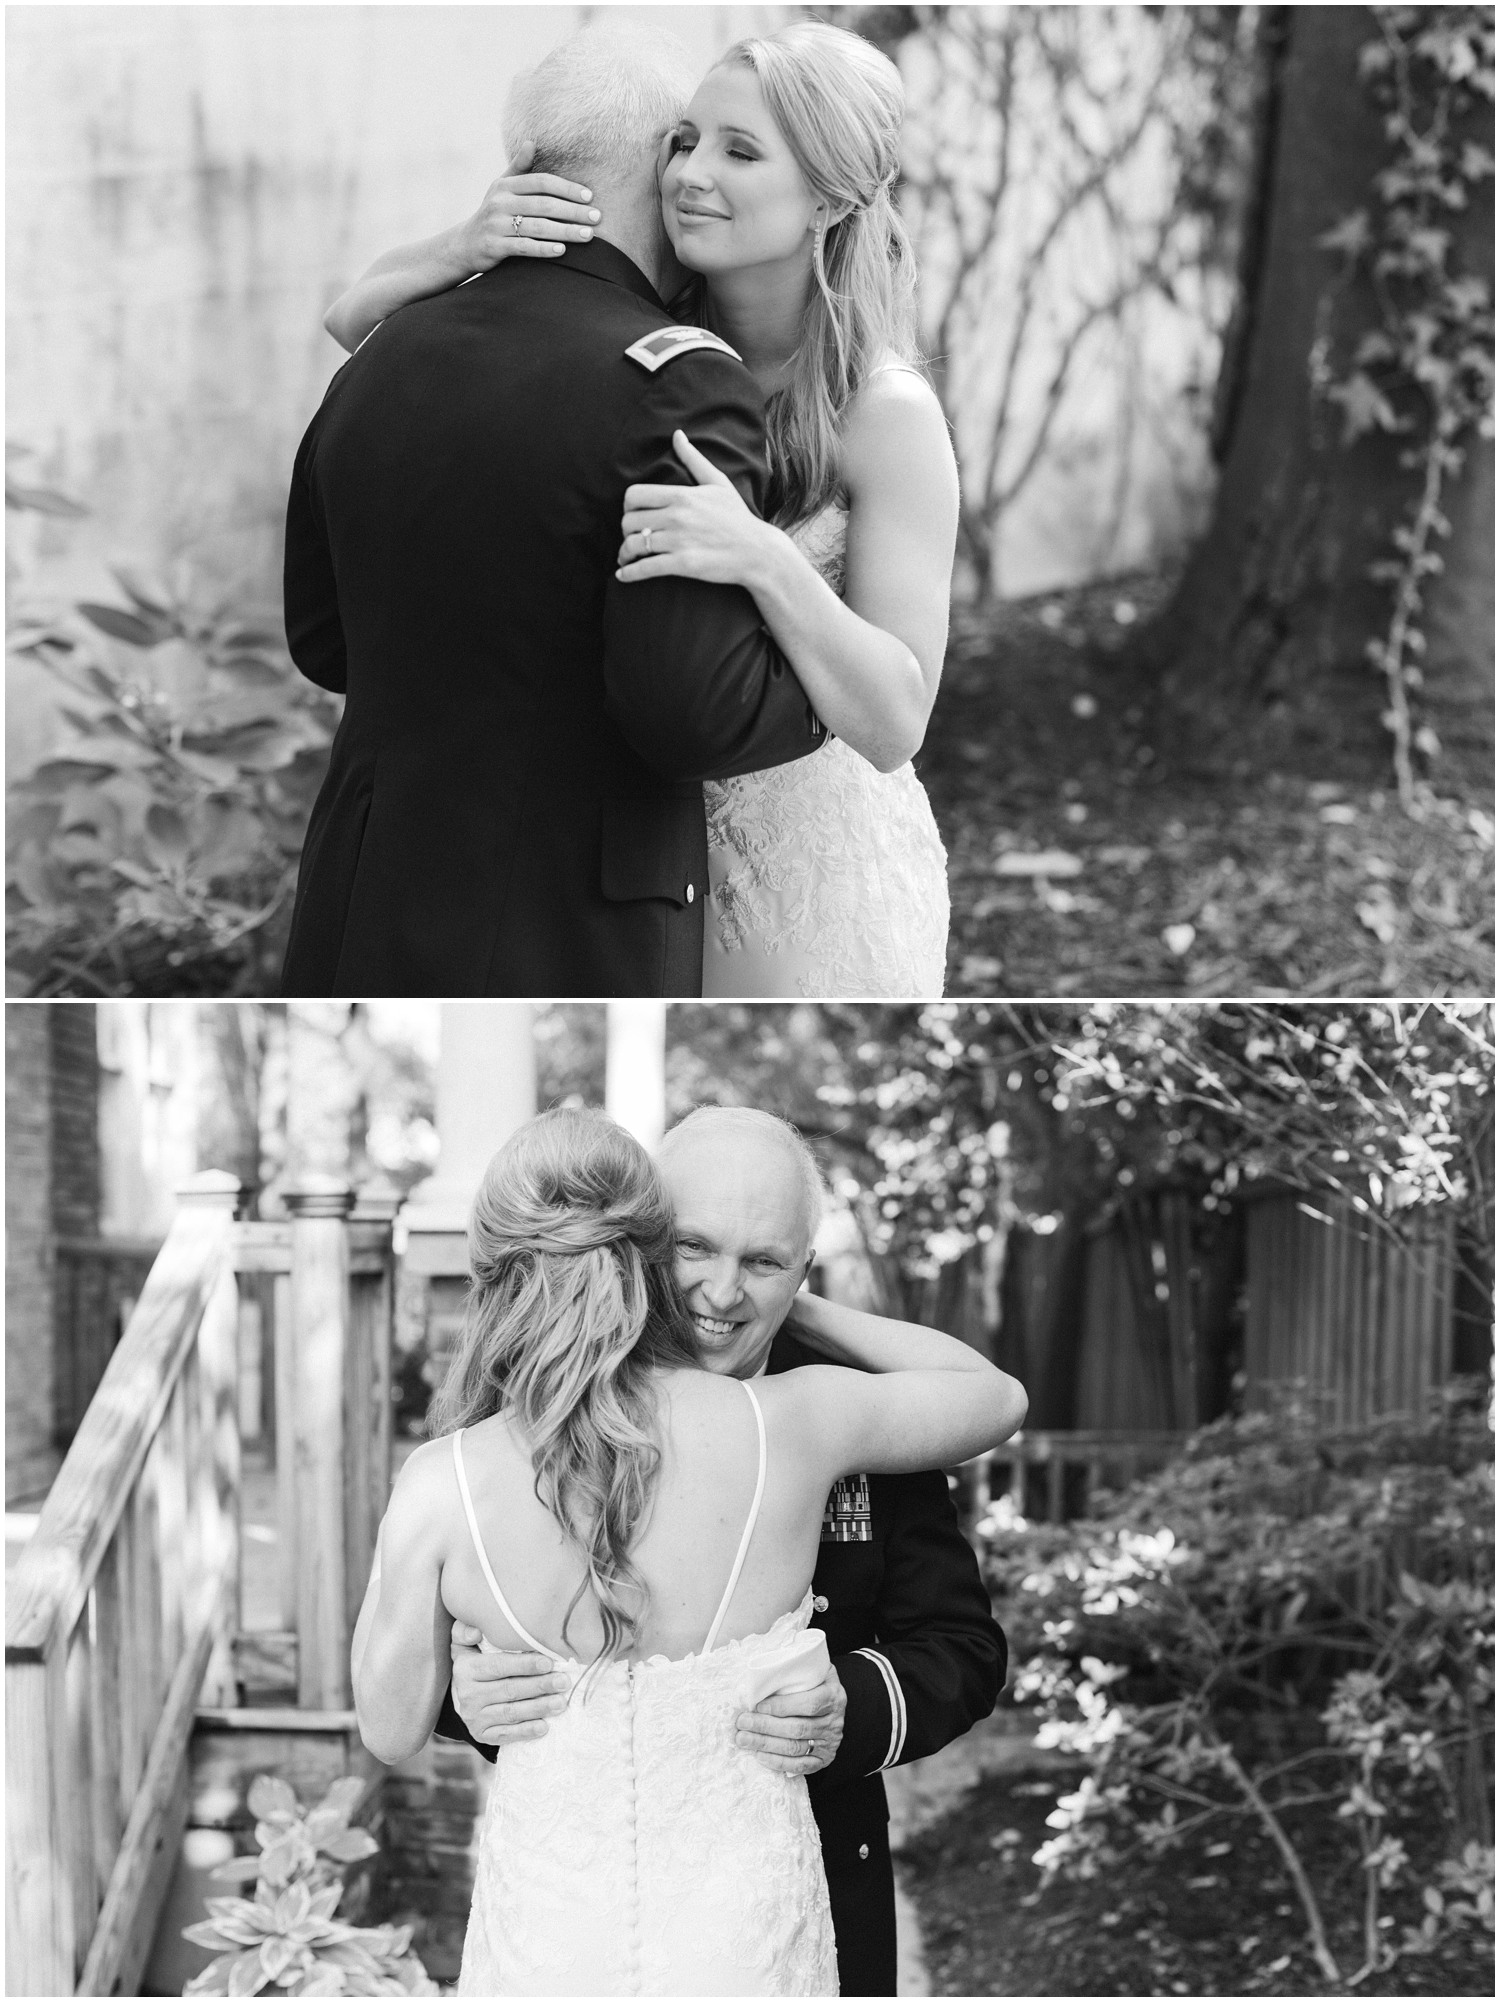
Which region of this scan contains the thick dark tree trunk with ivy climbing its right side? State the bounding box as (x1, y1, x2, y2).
(1142, 6, 1494, 767)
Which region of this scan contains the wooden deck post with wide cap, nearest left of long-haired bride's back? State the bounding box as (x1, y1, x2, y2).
(276, 1175, 354, 1710)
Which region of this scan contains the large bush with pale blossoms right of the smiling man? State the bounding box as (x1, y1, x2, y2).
(981, 1385, 1494, 1986)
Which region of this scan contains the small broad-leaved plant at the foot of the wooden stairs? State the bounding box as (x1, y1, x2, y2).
(182, 1774, 439, 1996)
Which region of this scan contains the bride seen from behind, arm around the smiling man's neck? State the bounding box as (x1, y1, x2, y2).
(352, 1111, 1023, 1996)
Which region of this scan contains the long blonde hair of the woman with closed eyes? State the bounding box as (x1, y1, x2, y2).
(721, 20, 917, 527)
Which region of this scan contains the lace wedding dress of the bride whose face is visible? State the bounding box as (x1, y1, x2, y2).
(703, 503, 947, 1001)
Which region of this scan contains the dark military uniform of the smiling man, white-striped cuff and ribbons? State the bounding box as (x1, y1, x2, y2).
(437, 1333, 1005, 1996)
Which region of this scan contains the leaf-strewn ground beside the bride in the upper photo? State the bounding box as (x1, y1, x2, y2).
(917, 577, 1494, 997)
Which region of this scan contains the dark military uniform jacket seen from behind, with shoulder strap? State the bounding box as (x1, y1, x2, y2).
(282, 242, 825, 997)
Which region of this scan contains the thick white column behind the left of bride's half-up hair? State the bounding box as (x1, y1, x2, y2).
(401, 1001, 537, 1271)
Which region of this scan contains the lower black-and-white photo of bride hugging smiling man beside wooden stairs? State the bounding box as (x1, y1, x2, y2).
(6, 1001, 1494, 1996)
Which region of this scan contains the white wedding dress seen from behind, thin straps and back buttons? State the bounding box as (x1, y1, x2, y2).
(453, 1383, 837, 1996)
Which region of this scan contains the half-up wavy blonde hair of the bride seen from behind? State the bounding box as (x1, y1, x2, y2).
(431, 1111, 699, 1666)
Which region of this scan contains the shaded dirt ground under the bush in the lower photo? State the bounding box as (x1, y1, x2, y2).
(899, 1770, 1494, 1996)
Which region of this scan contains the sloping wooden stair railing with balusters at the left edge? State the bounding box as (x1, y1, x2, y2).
(6, 1173, 238, 1996)
